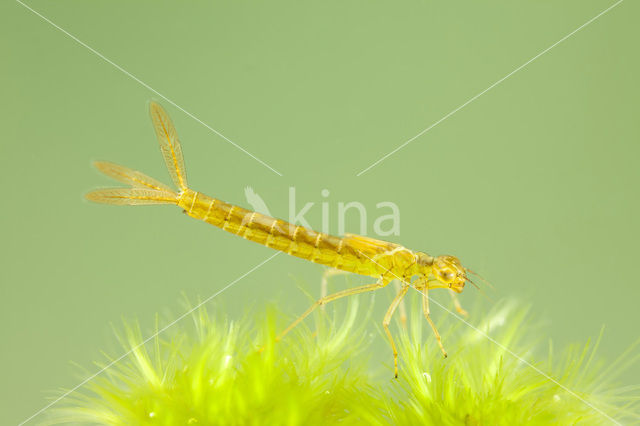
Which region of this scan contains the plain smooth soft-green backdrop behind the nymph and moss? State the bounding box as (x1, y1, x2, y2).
(0, 0, 640, 424)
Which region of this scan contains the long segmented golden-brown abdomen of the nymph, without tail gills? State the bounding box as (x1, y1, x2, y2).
(178, 190, 380, 277)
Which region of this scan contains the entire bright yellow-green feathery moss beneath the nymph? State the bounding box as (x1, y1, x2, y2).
(49, 297, 640, 425)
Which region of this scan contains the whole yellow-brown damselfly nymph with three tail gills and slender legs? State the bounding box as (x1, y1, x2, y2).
(87, 102, 467, 377)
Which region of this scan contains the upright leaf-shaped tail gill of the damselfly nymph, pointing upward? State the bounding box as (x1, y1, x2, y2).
(149, 102, 187, 190)
